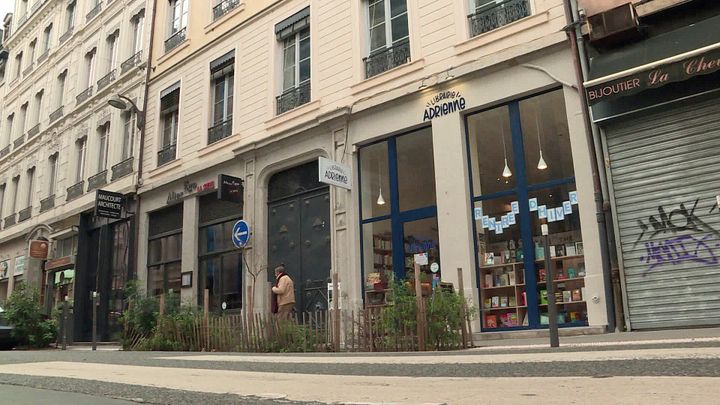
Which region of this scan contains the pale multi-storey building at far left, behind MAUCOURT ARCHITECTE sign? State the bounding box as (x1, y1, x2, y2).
(0, 0, 150, 341)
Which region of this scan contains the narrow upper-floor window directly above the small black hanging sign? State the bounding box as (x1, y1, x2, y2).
(208, 51, 235, 144)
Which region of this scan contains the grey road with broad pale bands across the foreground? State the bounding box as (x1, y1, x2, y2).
(0, 338, 720, 405)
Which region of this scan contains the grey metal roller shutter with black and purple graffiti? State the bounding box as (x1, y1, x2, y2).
(606, 99, 720, 329)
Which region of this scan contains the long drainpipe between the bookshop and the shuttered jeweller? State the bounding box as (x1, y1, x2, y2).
(563, 0, 622, 331)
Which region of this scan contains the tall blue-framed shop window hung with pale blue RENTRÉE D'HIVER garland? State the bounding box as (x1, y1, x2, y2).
(467, 90, 587, 330)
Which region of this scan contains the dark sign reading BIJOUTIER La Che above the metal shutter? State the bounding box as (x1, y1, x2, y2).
(586, 48, 720, 105)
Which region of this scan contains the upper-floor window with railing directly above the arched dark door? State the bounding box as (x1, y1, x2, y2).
(275, 7, 310, 114)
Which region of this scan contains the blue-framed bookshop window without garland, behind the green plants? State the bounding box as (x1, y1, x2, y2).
(360, 128, 441, 306)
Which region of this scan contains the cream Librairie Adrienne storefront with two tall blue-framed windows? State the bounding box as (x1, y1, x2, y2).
(350, 51, 607, 332)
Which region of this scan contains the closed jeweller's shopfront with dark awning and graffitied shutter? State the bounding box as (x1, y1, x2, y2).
(581, 1, 720, 329)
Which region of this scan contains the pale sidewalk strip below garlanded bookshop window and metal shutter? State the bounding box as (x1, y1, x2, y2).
(475, 328, 720, 349)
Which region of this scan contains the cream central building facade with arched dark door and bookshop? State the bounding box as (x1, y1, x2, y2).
(137, 0, 611, 332)
